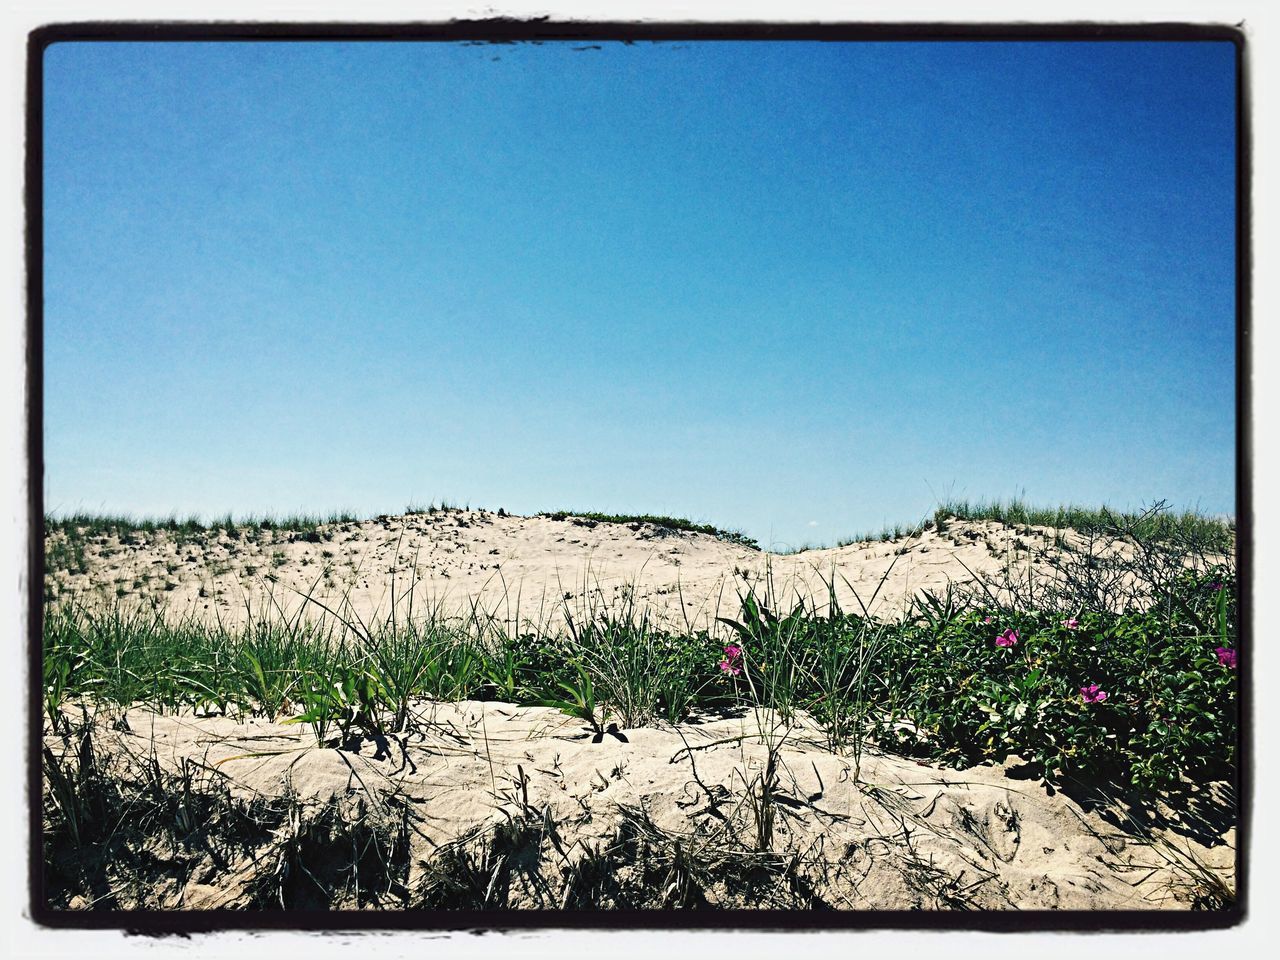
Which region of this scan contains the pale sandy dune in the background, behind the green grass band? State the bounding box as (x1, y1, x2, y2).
(50, 511, 1070, 626)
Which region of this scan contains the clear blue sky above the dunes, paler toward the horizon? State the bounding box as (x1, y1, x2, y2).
(45, 42, 1235, 545)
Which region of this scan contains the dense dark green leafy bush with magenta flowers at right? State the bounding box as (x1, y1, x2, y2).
(881, 580, 1238, 790)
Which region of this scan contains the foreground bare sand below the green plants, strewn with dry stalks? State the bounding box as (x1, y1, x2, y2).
(55, 701, 1234, 910)
